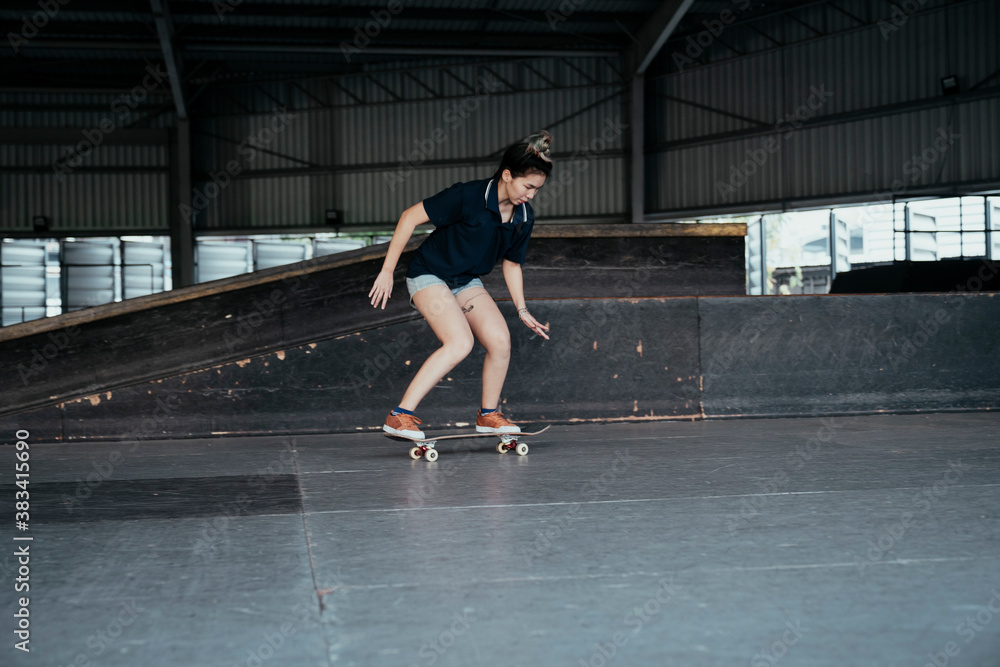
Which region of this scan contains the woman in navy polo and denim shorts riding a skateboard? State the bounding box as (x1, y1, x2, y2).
(368, 132, 552, 439)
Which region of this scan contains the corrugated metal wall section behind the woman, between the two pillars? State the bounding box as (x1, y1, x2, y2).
(194, 59, 627, 230)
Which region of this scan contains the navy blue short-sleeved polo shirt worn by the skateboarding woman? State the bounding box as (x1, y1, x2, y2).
(406, 179, 535, 288)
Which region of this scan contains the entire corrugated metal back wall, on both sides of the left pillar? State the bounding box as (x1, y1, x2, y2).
(0, 58, 626, 233)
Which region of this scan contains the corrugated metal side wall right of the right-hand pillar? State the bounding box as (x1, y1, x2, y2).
(646, 0, 1000, 217)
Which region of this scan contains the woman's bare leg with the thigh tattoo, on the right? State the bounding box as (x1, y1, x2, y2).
(458, 287, 510, 409)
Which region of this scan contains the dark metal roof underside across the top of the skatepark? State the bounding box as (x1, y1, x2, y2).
(0, 0, 860, 90)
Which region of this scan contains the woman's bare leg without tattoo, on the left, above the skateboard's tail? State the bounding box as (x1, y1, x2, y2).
(399, 285, 474, 410)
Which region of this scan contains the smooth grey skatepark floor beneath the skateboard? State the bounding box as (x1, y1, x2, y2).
(0, 413, 1000, 667)
